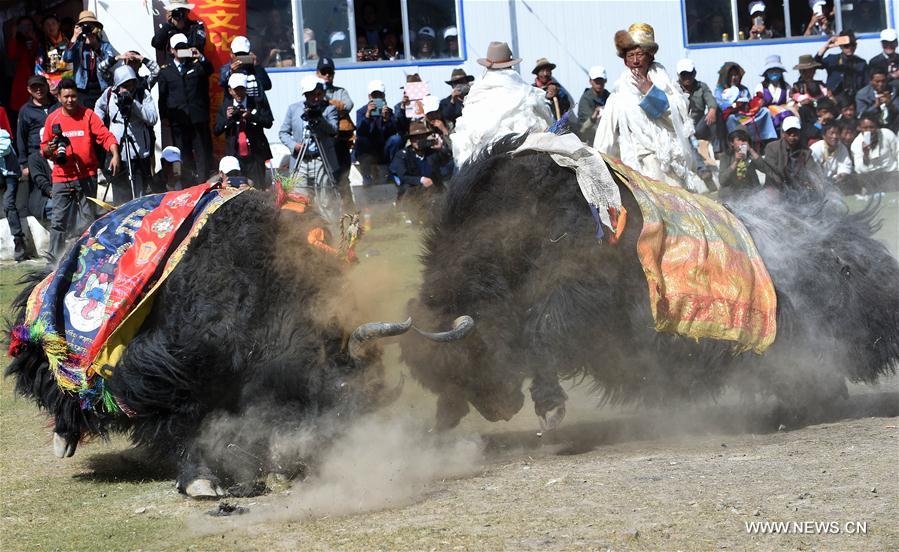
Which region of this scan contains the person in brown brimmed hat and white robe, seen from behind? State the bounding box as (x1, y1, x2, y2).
(453, 42, 553, 166)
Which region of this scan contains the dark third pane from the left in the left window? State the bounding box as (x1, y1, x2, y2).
(355, 0, 405, 62)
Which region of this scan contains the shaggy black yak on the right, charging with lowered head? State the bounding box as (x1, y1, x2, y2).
(401, 136, 899, 428)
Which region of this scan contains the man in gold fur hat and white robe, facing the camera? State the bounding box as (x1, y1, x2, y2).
(593, 23, 707, 192)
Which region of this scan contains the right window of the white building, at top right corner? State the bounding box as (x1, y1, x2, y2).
(683, 0, 888, 46)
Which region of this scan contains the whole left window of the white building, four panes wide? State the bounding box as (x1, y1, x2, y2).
(247, 0, 461, 67)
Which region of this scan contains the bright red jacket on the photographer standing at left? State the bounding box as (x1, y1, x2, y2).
(41, 107, 118, 182)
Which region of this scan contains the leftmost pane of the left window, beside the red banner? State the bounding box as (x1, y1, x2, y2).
(247, 0, 297, 67)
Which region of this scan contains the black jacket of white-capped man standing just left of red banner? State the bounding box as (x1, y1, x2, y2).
(159, 59, 212, 124)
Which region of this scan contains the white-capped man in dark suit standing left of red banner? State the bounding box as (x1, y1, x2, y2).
(159, 33, 213, 189)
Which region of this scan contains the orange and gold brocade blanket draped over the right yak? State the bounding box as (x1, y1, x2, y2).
(603, 156, 777, 353)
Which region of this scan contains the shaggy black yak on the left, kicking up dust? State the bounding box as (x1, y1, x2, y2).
(6, 191, 472, 497)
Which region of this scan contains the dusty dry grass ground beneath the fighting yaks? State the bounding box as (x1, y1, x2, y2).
(0, 194, 899, 551)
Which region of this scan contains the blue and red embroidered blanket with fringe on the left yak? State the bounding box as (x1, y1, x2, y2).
(9, 184, 243, 412)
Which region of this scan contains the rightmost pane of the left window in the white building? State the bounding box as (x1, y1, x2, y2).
(408, 0, 461, 60)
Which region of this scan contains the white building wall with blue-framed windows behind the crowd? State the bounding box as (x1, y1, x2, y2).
(95, 0, 899, 147)
